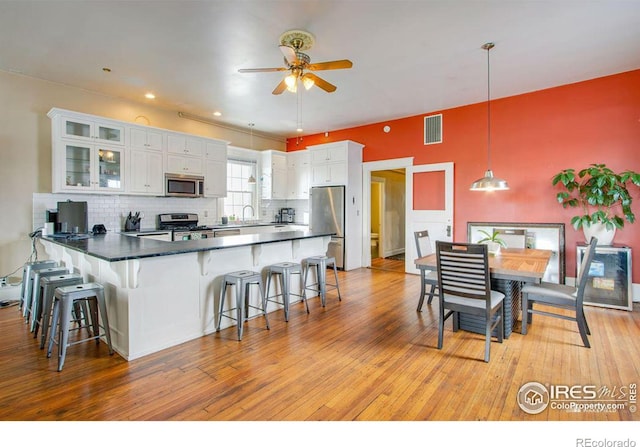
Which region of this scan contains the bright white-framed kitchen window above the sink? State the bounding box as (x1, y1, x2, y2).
(223, 159, 257, 219)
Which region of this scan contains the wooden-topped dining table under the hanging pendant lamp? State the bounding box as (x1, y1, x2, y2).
(415, 248, 553, 338)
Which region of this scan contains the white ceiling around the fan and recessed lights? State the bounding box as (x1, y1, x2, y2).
(0, 0, 640, 137)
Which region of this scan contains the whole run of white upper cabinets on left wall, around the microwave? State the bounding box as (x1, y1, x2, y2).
(47, 108, 228, 197)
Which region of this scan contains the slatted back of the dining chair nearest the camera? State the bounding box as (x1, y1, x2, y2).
(436, 241, 491, 300)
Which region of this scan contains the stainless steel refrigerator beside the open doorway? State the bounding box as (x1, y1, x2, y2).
(309, 186, 345, 269)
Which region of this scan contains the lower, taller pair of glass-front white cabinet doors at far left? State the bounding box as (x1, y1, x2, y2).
(52, 139, 124, 193)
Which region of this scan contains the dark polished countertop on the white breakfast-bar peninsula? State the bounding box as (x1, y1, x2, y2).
(42, 231, 332, 262)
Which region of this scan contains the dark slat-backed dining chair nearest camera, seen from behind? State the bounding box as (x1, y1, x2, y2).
(436, 241, 504, 362)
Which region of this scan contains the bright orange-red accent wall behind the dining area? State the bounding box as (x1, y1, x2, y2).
(287, 70, 640, 283)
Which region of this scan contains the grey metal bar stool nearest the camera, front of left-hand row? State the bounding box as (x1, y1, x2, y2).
(47, 282, 113, 371)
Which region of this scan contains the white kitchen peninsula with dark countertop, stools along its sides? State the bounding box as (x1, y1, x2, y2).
(40, 231, 331, 360)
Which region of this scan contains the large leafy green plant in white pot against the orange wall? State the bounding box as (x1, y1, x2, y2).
(551, 164, 640, 245)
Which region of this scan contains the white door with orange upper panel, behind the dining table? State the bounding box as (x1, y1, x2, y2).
(405, 162, 453, 273)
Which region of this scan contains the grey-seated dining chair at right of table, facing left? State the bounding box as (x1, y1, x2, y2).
(520, 237, 598, 348)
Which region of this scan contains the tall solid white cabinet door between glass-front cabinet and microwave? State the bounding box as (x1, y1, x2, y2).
(127, 150, 164, 196)
